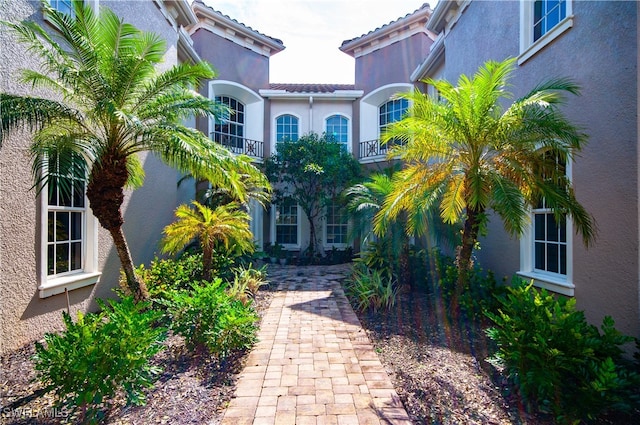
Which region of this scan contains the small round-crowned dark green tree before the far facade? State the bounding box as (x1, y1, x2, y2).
(265, 133, 361, 256)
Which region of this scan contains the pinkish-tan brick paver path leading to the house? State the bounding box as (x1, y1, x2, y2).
(222, 266, 411, 425)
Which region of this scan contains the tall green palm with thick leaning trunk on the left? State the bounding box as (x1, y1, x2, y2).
(0, 1, 259, 300)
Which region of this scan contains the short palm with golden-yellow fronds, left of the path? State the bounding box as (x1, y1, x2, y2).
(162, 201, 254, 280)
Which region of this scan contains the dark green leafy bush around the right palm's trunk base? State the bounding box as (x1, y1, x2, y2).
(432, 251, 506, 321)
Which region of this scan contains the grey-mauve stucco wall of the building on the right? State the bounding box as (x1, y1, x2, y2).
(445, 1, 640, 336)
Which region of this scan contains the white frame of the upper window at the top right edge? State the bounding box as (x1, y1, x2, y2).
(518, 0, 574, 65)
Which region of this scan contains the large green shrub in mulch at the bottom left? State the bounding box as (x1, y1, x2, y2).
(34, 297, 166, 422)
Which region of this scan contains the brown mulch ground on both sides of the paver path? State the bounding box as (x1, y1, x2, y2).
(0, 266, 634, 425)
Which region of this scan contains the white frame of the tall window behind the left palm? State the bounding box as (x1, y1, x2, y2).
(38, 157, 102, 298)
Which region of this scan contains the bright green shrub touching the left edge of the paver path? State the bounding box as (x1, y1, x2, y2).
(167, 278, 258, 357)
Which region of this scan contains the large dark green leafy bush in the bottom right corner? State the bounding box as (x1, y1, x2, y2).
(487, 284, 640, 423)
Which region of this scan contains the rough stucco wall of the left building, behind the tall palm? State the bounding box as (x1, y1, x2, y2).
(0, 0, 193, 353)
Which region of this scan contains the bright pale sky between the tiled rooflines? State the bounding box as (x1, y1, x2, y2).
(204, 0, 437, 84)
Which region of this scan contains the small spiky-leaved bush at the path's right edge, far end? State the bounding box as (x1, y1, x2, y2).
(345, 264, 398, 311)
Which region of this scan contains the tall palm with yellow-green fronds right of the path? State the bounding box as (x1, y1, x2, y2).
(375, 59, 595, 306)
